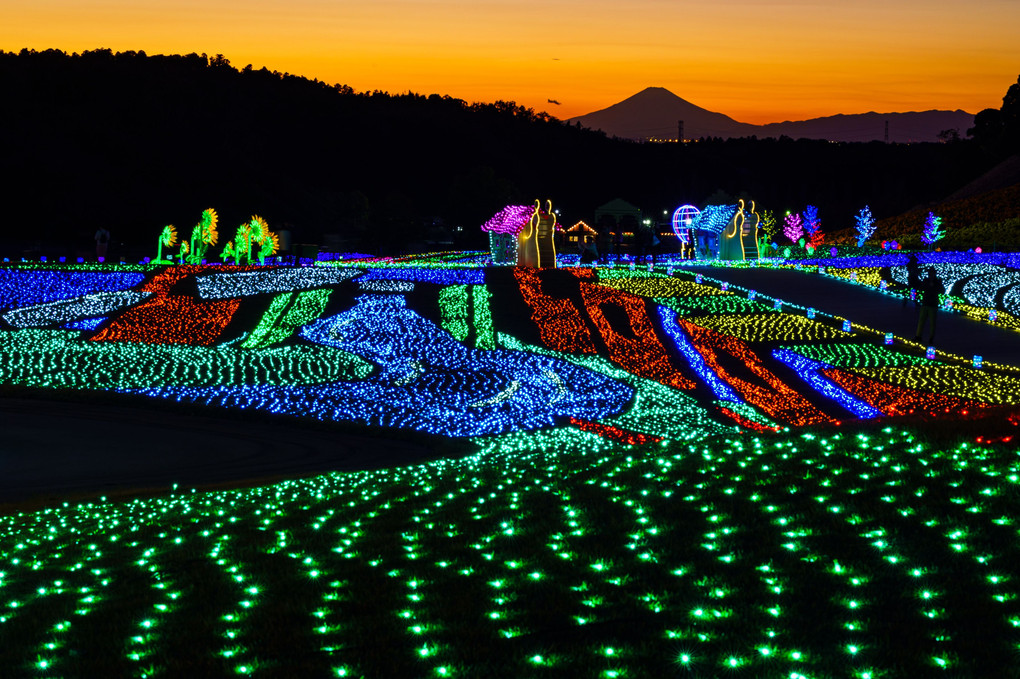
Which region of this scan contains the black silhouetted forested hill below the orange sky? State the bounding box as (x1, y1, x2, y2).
(0, 49, 1012, 254)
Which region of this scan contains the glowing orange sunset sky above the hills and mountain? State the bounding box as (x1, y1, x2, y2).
(0, 0, 1020, 123)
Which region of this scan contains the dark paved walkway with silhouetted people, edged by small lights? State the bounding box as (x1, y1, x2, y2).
(674, 266, 1020, 371)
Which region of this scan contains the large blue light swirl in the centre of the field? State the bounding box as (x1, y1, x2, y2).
(130, 295, 633, 436)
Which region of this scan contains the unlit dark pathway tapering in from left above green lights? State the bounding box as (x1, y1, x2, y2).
(0, 398, 463, 509)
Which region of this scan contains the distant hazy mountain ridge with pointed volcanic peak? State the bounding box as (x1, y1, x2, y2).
(569, 88, 974, 143)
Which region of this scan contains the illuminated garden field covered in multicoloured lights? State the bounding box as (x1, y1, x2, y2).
(0, 231, 1020, 679)
